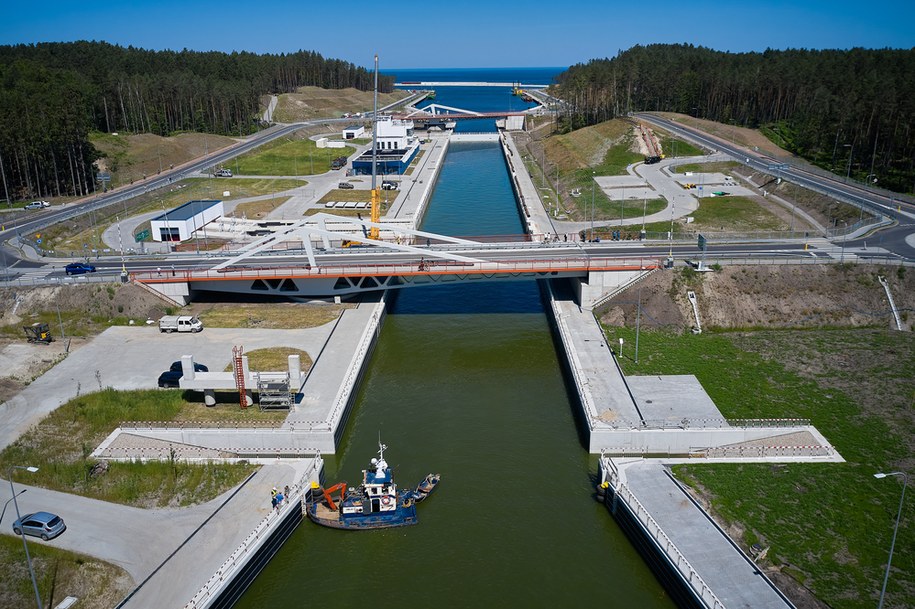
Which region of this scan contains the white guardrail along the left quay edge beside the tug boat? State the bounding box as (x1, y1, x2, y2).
(184, 455, 324, 609)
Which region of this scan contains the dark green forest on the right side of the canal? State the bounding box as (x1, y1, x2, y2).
(557, 44, 915, 192)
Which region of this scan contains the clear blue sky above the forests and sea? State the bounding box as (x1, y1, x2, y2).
(0, 0, 915, 69)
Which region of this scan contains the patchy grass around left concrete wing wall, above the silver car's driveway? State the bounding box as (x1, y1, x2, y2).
(0, 389, 256, 507)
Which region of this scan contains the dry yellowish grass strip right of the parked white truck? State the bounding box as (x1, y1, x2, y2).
(189, 303, 350, 329)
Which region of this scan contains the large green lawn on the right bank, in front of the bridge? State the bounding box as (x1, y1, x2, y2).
(608, 328, 915, 608)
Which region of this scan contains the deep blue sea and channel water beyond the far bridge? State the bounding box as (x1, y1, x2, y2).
(382, 68, 564, 133)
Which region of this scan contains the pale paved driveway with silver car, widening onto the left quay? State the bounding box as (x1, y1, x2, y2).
(0, 459, 311, 609)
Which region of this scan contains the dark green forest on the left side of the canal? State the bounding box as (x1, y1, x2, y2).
(0, 41, 394, 200)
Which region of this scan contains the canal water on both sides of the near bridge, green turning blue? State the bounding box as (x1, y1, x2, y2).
(237, 144, 674, 609)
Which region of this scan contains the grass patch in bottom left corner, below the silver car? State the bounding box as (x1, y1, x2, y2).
(0, 532, 132, 607)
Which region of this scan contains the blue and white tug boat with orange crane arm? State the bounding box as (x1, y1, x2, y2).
(305, 442, 441, 529)
